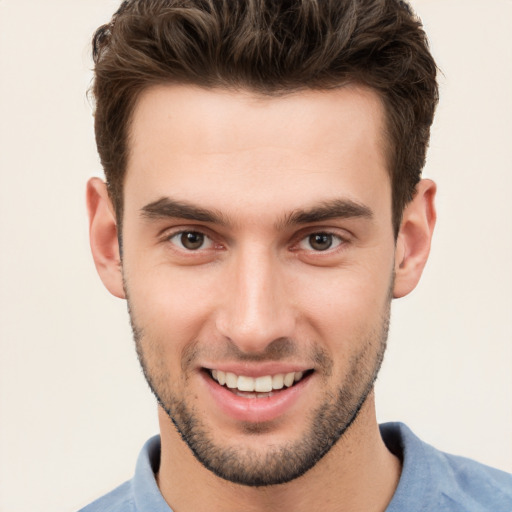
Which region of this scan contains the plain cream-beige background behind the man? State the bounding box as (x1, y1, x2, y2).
(0, 0, 512, 512)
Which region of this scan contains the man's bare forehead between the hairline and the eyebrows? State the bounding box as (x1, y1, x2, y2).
(125, 85, 391, 224)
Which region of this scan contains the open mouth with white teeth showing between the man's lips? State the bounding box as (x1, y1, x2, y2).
(205, 369, 313, 398)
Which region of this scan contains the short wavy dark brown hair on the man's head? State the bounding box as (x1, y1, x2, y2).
(92, 0, 438, 234)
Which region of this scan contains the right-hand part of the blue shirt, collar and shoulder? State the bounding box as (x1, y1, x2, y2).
(381, 423, 512, 512)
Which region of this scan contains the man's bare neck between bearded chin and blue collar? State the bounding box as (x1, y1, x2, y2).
(158, 393, 401, 512)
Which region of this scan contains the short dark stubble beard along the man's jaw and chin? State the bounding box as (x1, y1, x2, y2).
(128, 300, 391, 487)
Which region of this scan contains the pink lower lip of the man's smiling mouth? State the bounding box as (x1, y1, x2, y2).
(203, 373, 312, 423)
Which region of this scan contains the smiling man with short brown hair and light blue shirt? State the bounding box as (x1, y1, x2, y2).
(80, 0, 512, 512)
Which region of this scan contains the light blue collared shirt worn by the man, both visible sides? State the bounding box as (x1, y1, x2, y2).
(80, 423, 512, 512)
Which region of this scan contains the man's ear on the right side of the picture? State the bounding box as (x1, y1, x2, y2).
(393, 180, 436, 298)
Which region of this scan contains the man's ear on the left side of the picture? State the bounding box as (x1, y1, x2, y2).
(87, 178, 125, 299)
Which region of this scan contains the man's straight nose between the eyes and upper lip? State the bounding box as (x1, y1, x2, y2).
(217, 246, 295, 354)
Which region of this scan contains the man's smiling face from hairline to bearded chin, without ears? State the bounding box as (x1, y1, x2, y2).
(122, 86, 395, 485)
